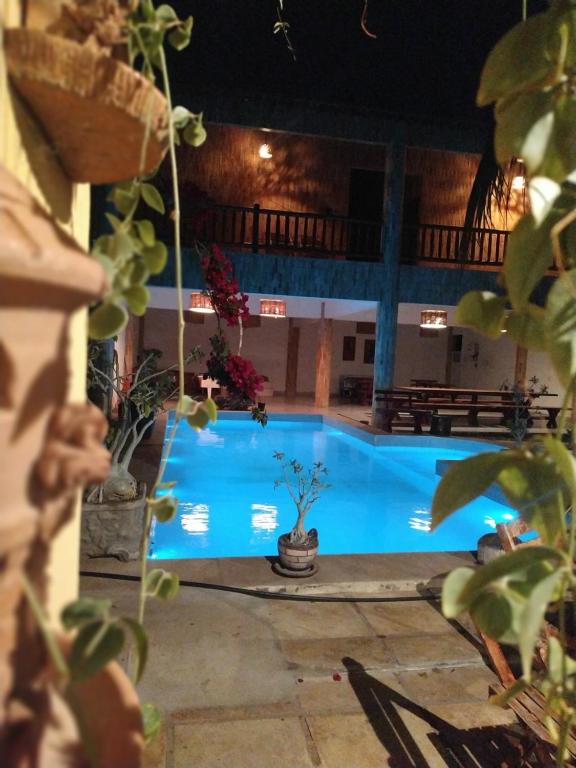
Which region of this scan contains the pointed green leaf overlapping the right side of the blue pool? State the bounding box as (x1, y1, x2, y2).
(432, 451, 512, 529)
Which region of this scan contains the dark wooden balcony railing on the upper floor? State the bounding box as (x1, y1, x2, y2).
(182, 204, 510, 268)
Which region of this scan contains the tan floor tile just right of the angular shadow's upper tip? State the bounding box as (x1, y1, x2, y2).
(399, 666, 498, 703)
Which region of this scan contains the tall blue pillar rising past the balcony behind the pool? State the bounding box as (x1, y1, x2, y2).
(372, 141, 406, 427)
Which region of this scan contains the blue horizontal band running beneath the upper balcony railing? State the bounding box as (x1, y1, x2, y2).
(151, 249, 549, 305)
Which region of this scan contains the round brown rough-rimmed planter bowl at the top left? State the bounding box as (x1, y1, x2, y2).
(4, 28, 168, 184)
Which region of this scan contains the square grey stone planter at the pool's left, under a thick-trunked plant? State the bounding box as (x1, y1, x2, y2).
(80, 483, 146, 562)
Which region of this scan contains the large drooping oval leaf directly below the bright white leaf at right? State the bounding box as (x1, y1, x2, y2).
(504, 214, 553, 310)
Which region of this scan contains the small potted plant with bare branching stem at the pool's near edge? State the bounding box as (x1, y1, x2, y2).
(274, 451, 330, 576)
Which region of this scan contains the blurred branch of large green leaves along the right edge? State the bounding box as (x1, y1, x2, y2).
(432, 0, 576, 766)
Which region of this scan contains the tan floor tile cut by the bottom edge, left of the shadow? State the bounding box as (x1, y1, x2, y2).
(173, 718, 318, 768)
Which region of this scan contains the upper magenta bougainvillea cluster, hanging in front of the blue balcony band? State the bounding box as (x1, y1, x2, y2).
(202, 245, 250, 326)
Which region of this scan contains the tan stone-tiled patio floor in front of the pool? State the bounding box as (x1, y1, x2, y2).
(82, 558, 514, 768)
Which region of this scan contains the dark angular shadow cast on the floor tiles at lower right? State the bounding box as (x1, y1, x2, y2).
(342, 657, 532, 768)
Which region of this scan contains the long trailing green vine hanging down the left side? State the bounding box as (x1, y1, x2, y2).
(24, 0, 217, 752)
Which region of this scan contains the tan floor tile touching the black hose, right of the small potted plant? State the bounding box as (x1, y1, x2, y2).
(358, 601, 455, 637)
